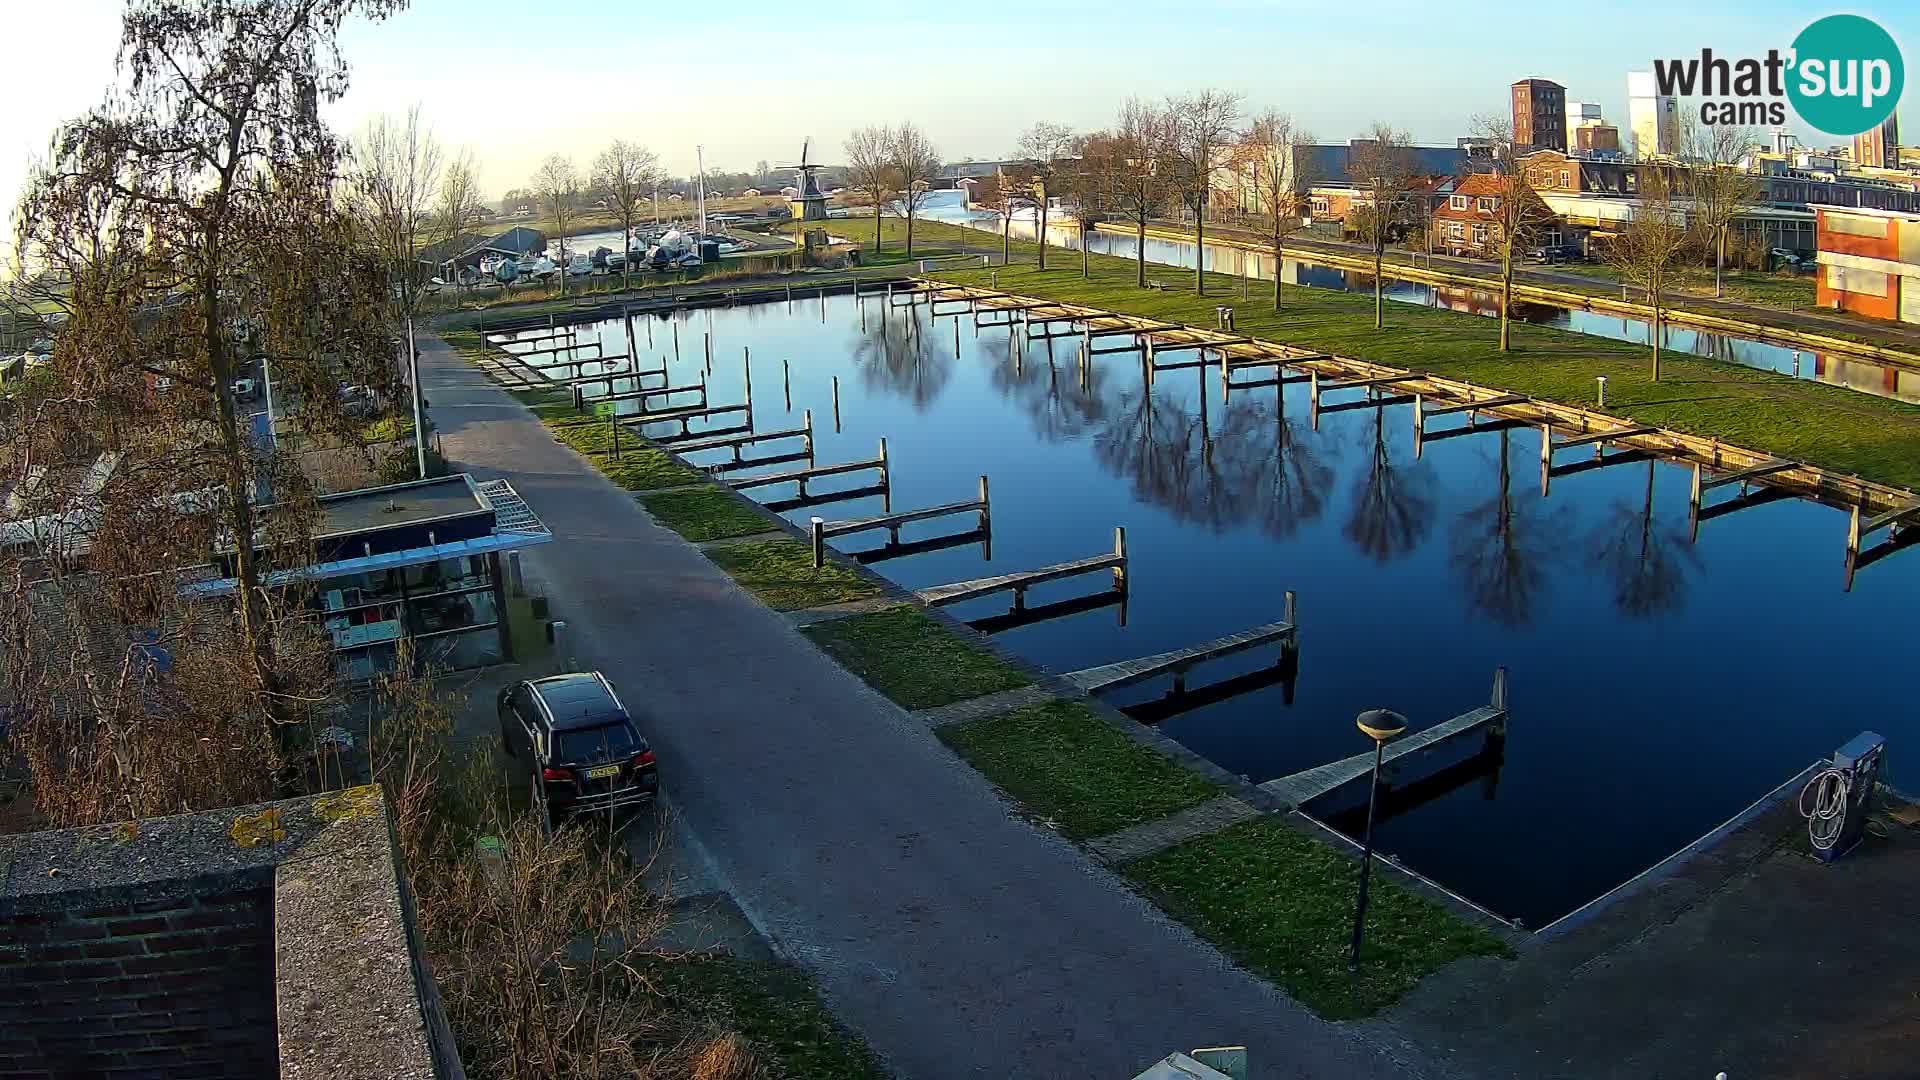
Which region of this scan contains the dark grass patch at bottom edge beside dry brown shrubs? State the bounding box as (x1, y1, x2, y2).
(639, 955, 887, 1080)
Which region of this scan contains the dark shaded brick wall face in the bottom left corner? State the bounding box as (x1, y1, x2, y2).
(0, 888, 278, 1080)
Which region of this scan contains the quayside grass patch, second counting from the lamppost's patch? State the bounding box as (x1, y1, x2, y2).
(939, 701, 1221, 840)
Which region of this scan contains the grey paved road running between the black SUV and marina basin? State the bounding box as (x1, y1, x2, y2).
(420, 334, 1444, 1080)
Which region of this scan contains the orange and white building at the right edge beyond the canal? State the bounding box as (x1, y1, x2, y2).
(1812, 206, 1920, 323)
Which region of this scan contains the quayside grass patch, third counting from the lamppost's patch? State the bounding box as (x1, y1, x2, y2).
(804, 607, 1033, 709)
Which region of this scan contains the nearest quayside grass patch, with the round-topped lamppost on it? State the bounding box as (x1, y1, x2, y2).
(1121, 817, 1507, 1020)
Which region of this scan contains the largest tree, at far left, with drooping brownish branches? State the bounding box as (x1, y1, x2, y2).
(0, 0, 397, 810)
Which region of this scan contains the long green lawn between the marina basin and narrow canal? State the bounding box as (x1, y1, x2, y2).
(835, 219, 1920, 488)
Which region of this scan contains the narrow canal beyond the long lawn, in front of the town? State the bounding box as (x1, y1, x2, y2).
(922, 192, 1920, 404)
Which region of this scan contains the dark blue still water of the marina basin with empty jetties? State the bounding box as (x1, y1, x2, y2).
(506, 296, 1920, 926)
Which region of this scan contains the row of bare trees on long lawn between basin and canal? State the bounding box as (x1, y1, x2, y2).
(847, 90, 1761, 380)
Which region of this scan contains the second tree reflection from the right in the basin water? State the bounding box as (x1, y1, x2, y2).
(1452, 430, 1567, 626)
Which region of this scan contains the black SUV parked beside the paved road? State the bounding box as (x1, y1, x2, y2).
(499, 671, 660, 824)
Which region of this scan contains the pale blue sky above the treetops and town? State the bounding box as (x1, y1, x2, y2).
(0, 0, 1920, 220)
